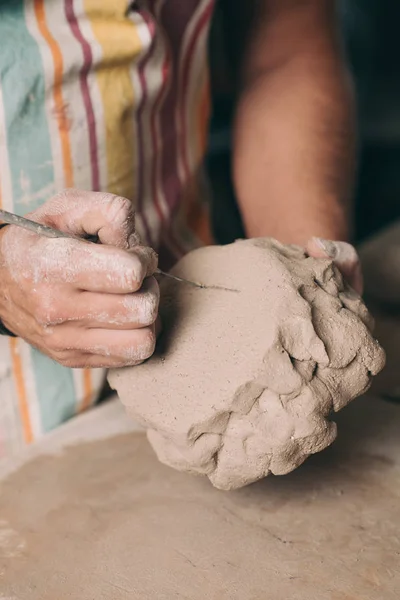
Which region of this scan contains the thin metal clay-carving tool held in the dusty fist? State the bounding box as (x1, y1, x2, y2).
(0, 209, 238, 292)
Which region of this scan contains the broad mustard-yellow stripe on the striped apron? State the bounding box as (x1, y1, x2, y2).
(84, 0, 142, 200)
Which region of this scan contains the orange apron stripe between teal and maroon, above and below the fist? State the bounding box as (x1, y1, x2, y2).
(34, 0, 93, 410)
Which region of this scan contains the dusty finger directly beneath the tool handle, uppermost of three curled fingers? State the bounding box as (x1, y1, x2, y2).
(30, 238, 154, 294)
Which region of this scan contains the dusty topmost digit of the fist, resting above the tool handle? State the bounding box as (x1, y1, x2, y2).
(32, 189, 140, 249)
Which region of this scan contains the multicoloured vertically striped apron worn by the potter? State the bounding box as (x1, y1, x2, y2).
(0, 0, 214, 458)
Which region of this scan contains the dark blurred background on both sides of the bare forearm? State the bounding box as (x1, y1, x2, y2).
(207, 0, 400, 244)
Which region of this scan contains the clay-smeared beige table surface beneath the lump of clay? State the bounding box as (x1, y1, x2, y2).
(0, 390, 400, 600)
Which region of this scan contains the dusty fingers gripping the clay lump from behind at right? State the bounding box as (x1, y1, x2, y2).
(306, 237, 363, 295)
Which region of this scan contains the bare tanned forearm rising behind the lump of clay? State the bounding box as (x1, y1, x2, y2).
(234, 3, 355, 245)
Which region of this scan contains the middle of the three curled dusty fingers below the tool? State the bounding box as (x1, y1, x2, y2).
(54, 277, 160, 329)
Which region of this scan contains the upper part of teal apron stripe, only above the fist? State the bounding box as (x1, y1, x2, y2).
(0, 0, 54, 214)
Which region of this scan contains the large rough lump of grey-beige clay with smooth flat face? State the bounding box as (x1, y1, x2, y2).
(109, 239, 385, 490)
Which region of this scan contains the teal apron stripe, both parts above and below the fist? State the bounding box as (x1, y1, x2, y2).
(0, 0, 76, 431)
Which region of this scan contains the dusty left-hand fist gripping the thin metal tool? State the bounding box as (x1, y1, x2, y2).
(0, 190, 159, 367)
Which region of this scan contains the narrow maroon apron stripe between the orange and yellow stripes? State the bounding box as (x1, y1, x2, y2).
(65, 0, 100, 192)
